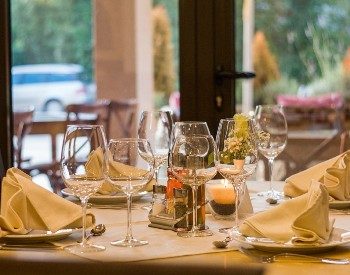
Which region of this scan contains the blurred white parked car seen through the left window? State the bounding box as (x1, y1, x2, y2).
(12, 64, 91, 111)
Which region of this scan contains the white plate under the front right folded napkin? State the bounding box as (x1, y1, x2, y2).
(233, 228, 350, 253)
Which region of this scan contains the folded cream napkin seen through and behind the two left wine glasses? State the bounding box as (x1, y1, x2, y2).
(86, 148, 155, 195)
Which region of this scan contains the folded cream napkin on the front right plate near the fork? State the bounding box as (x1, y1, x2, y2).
(239, 181, 334, 244)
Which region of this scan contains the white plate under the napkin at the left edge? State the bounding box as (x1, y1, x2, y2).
(1, 229, 78, 243)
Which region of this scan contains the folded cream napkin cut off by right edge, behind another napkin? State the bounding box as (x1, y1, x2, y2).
(284, 150, 350, 200)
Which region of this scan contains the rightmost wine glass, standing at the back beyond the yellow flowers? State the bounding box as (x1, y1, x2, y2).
(255, 105, 288, 201)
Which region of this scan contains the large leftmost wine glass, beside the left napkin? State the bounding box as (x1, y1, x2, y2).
(60, 125, 107, 254)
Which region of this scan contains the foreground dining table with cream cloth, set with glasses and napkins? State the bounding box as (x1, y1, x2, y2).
(0, 181, 350, 275)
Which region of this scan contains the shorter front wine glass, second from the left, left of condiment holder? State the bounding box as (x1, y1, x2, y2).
(108, 138, 154, 247)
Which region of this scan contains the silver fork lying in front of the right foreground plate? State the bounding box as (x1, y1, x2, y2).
(239, 247, 350, 265)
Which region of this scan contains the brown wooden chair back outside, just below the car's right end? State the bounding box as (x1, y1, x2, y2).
(66, 99, 111, 138)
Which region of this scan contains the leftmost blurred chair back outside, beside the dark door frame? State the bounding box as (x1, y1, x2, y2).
(13, 107, 34, 168)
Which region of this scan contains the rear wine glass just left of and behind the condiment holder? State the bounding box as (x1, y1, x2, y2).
(138, 111, 173, 185)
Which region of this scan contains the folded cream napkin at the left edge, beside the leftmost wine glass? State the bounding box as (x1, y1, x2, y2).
(0, 168, 95, 236)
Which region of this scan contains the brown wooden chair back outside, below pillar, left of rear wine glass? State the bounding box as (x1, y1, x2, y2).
(111, 99, 138, 137)
